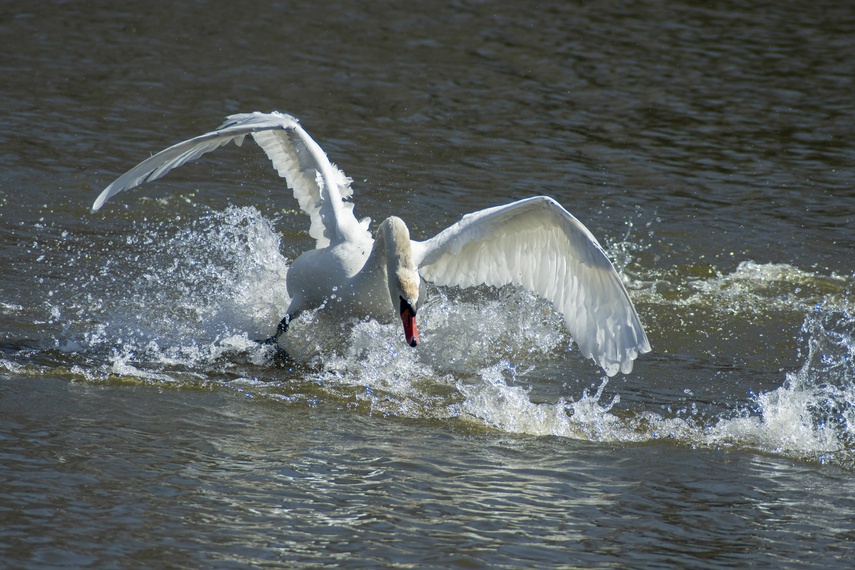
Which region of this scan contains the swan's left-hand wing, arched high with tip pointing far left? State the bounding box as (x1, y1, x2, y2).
(92, 112, 368, 247)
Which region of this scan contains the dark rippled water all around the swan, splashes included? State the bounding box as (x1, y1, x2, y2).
(0, 2, 855, 568)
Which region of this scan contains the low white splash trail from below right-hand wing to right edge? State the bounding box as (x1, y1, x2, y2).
(432, 282, 855, 468)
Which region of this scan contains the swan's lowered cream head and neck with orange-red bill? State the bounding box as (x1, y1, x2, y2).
(381, 216, 420, 346)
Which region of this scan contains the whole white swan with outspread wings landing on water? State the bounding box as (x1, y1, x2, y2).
(92, 112, 650, 376)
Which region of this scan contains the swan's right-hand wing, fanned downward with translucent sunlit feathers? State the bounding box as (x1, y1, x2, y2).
(413, 196, 650, 376)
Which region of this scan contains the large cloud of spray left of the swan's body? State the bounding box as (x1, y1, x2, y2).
(57, 208, 289, 364)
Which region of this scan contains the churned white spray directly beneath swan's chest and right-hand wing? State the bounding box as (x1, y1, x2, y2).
(282, 290, 580, 419)
